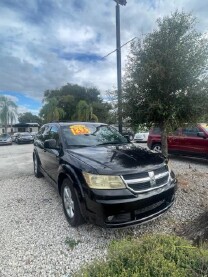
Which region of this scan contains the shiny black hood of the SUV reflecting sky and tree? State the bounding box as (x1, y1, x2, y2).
(66, 144, 164, 174)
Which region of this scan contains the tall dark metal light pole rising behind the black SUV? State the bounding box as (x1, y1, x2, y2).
(114, 0, 127, 133)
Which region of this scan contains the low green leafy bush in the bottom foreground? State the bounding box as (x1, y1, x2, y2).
(75, 235, 208, 277)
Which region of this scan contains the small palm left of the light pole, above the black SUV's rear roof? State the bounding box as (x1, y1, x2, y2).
(40, 97, 65, 122)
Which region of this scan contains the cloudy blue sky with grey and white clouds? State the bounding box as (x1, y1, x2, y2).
(0, 0, 208, 114)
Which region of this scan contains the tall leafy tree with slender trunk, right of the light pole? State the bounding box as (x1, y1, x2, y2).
(124, 11, 208, 156)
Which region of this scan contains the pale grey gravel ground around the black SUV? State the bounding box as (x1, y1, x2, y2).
(0, 143, 208, 277)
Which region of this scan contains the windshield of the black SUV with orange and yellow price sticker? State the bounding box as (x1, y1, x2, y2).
(62, 123, 128, 147)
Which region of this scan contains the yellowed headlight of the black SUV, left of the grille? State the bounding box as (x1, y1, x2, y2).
(83, 172, 126, 189)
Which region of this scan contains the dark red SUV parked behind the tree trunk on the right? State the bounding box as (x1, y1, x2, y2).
(147, 123, 208, 158)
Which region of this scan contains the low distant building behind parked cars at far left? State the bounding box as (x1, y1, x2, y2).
(0, 123, 40, 134)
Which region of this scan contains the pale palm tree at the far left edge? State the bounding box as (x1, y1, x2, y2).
(0, 95, 17, 133)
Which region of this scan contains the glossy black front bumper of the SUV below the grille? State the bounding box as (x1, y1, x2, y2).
(83, 182, 177, 228)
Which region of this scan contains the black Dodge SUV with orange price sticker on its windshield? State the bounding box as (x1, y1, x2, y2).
(33, 122, 176, 228)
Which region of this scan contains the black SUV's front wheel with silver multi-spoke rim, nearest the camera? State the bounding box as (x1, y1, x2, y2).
(61, 178, 84, 227)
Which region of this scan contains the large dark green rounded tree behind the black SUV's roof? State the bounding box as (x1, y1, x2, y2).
(40, 84, 111, 122)
